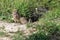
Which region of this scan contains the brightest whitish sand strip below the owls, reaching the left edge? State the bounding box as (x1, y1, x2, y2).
(0, 22, 26, 32)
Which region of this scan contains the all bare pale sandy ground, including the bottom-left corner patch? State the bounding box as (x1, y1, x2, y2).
(0, 21, 36, 40)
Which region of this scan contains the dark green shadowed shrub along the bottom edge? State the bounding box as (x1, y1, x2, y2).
(25, 33, 49, 40)
